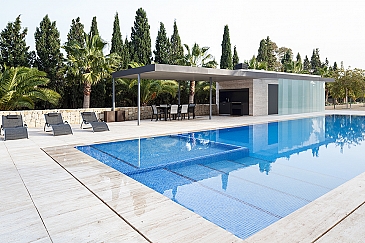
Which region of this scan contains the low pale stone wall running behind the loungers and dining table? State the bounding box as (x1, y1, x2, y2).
(0, 104, 218, 128)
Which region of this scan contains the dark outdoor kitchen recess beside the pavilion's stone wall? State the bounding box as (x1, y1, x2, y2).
(219, 89, 249, 116)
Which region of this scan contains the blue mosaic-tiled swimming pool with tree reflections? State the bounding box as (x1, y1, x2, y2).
(78, 115, 365, 239)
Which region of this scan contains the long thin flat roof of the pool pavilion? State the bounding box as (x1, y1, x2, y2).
(112, 64, 334, 82)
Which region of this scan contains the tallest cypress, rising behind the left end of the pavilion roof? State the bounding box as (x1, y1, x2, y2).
(130, 8, 152, 64)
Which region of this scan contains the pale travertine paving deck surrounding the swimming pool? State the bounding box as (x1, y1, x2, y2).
(0, 110, 365, 242)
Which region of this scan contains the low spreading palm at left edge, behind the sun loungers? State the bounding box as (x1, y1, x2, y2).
(0, 67, 60, 110)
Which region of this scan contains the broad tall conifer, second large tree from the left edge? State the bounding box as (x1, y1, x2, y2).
(34, 15, 64, 108)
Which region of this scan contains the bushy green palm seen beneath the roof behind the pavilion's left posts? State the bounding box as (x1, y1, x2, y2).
(117, 63, 178, 105)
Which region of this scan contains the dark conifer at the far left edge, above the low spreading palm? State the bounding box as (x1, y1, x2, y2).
(0, 15, 31, 67)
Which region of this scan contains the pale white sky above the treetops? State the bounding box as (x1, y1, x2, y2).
(0, 0, 365, 69)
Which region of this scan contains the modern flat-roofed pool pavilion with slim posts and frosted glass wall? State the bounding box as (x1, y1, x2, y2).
(112, 64, 334, 125)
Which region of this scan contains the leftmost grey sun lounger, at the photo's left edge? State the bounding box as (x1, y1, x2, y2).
(0, 115, 28, 141)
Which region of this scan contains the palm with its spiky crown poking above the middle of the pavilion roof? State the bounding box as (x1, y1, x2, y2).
(179, 43, 218, 104)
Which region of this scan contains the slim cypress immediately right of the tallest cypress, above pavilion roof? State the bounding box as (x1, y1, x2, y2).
(153, 22, 170, 64)
